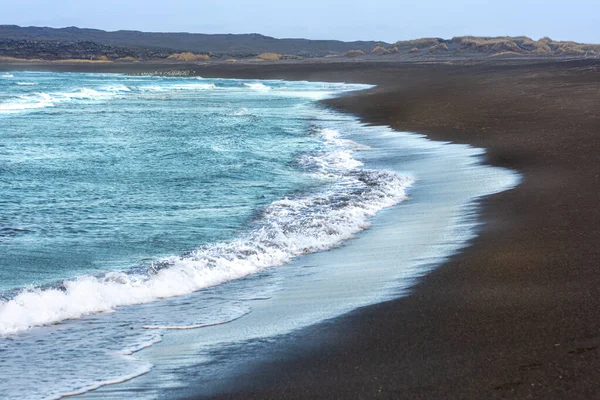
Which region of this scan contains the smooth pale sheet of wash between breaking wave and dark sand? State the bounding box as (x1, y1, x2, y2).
(71, 83, 519, 399)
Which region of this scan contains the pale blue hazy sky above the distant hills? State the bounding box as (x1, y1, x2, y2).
(0, 0, 600, 43)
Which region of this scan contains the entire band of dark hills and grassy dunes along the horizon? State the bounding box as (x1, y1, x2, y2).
(0, 25, 600, 62)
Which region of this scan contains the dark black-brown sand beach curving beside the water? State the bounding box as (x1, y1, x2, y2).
(4, 60, 600, 399)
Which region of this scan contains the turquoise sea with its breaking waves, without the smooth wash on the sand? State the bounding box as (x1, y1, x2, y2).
(0, 72, 420, 398)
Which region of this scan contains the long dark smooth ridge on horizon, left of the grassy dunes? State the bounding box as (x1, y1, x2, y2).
(0, 25, 378, 57)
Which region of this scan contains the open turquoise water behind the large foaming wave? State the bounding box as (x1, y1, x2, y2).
(0, 73, 354, 290)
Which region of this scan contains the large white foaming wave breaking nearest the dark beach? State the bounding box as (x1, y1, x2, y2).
(0, 129, 412, 335)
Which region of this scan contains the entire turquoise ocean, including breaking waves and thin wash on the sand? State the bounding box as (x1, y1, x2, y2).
(0, 72, 518, 399)
